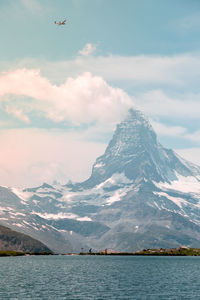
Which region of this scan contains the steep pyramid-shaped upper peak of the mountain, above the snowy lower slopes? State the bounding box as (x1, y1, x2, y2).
(81, 109, 198, 188)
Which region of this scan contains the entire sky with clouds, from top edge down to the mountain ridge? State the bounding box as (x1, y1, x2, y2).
(0, 0, 200, 187)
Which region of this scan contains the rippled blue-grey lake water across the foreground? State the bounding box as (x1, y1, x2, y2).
(0, 255, 200, 300)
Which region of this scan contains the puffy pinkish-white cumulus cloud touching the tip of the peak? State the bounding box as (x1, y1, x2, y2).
(0, 68, 133, 124)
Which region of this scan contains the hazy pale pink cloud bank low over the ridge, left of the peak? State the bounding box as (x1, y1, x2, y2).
(0, 129, 106, 186)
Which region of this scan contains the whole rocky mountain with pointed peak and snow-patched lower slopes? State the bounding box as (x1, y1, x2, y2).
(0, 110, 200, 252)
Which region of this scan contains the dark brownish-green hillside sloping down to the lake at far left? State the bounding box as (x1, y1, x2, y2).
(0, 225, 52, 253)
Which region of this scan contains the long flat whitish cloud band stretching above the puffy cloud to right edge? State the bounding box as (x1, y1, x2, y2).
(19, 53, 200, 89)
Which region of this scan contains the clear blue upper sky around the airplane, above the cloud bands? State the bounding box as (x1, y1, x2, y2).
(0, 0, 200, 60)
